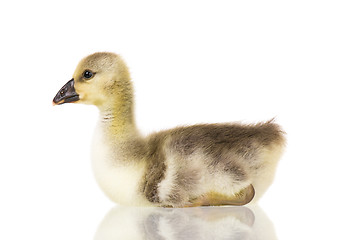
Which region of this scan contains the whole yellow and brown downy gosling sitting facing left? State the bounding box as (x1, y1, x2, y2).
(53, 52, 285, 207)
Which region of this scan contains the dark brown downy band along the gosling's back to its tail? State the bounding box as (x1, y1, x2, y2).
(167, 120, 284, 156)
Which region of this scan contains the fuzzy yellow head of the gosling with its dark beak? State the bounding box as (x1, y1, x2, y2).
(53, 52, 129, 107)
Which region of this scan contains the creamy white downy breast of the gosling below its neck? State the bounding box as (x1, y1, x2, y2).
(92, 123, 147, 205)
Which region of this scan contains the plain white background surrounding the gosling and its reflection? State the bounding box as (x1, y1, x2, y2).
(0, 0, 338, 239)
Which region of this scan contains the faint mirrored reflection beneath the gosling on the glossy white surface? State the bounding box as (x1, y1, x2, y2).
(94, 206, 277, 240)
